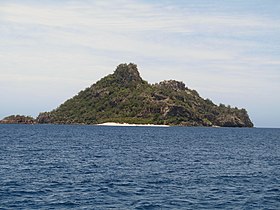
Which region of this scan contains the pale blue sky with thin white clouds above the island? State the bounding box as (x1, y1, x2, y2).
(0, 0, 280, 128)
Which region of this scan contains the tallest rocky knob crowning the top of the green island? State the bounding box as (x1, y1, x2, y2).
(114, 63, 142, 83)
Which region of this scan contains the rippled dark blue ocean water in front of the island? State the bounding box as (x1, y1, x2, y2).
(0, 125, 280, 209)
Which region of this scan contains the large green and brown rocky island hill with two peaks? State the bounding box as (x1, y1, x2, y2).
(36, 63, 253, 127)
